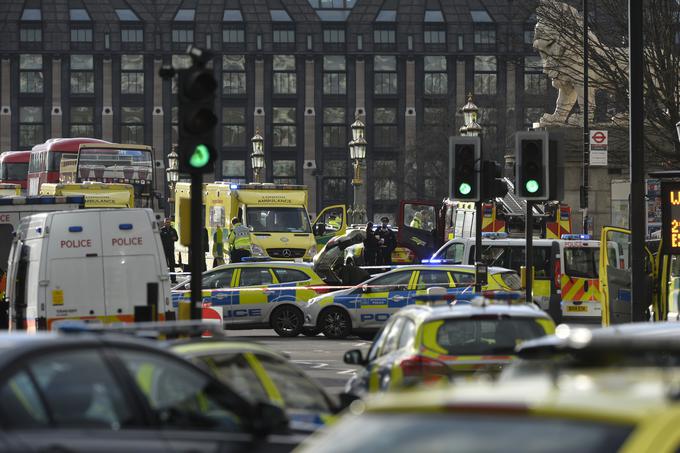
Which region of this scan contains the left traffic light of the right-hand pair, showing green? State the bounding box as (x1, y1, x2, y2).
(449, 137, 481, 201)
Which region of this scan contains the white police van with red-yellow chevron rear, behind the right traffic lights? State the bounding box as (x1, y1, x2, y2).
(432, 233, 604, 323)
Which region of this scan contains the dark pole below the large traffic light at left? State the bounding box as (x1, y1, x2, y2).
(189, 173, 205, 319)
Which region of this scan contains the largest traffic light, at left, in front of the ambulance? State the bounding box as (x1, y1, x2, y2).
(177, 61, 217, 173)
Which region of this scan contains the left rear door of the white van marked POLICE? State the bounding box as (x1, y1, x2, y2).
(45, 211, 106, 324)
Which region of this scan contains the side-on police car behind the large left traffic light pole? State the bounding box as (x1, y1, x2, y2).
(172, 262, 329, 337)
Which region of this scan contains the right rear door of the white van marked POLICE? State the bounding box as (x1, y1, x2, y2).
(100, 209, 166, 322)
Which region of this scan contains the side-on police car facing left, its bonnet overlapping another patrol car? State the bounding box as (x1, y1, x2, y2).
(304, 264, 520, 339)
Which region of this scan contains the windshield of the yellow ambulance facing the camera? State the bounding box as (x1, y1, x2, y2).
(246, 207, 312, 233)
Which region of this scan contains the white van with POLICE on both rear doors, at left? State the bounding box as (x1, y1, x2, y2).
(7, 209, 173, 331)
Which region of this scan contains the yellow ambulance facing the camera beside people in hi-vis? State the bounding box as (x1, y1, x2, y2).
(175, 181, 347, 263)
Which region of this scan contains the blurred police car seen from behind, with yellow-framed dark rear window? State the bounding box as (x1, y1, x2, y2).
(345, 294, 555, 396)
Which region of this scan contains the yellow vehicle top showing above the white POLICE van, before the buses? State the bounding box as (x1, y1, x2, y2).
(40, 182, 135, 208)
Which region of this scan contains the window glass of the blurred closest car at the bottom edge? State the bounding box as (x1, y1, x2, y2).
(302, 412, 632, 453)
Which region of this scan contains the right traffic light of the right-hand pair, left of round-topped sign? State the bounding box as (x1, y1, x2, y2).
(515, 131, 550, 200)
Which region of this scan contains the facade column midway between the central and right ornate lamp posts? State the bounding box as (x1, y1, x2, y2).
(404, 59, 418, 199)
